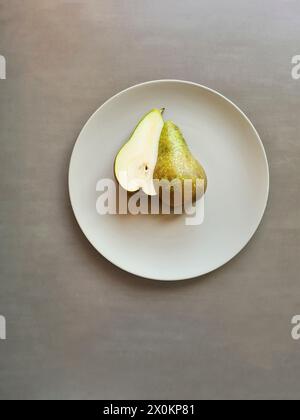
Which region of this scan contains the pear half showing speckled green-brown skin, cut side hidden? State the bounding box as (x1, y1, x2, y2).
(153, 121, 207, 207)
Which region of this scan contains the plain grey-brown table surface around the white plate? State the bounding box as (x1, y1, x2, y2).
(0, 0, 300, 399)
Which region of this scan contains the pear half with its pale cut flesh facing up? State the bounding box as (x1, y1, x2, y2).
(114, 109, 164, 195)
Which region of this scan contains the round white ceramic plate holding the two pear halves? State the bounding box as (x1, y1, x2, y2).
(69, 80, 269, 280)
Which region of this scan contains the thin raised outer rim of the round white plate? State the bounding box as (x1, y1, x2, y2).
(68, 79, 270, 282)
